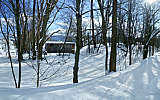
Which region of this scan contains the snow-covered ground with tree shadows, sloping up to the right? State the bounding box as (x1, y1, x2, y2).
(0, 45, 160, 100)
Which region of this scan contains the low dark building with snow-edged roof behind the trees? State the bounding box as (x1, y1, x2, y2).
(44, 33, 75, 53)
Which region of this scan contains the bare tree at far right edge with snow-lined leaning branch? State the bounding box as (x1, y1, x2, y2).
(143, 5, 160, 59)
